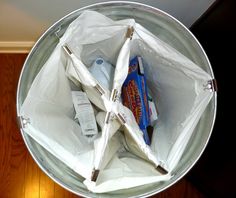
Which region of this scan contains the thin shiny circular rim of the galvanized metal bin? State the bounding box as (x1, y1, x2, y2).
(16, 1, 217, 197)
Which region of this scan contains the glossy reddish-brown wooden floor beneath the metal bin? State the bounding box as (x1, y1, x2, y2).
(0, 54, 204, 198)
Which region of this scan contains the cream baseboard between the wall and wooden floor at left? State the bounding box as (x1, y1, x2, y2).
(0, 41, 35, 53)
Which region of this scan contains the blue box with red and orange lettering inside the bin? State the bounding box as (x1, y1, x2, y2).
(122, 56, 151, 145)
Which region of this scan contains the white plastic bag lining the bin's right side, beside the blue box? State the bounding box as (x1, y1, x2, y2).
(131, 24, 213, 171)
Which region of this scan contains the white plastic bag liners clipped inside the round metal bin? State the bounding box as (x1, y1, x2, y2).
(20, 11, 213, 193)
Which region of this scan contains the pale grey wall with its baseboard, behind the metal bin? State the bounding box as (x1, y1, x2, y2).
(0, 0, 215, 52)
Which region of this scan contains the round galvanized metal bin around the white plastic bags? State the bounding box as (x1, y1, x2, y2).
(16, 2, 216, 198)
